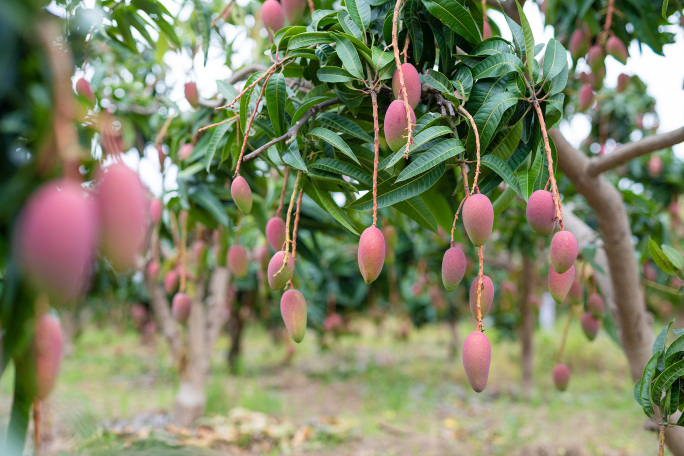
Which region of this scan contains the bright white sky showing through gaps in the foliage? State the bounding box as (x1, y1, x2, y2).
(65, 0, 684, 195)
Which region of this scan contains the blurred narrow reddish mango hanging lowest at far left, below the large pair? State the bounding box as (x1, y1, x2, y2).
(34, 314, 63, 400)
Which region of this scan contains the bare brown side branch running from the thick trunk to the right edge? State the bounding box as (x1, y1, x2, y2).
(587, 127, 684, 177)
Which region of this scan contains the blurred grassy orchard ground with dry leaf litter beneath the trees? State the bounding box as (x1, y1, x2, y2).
(0, 321, 657, 456)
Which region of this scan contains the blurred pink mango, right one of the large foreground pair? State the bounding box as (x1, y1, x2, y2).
(97, 163, 148, 270)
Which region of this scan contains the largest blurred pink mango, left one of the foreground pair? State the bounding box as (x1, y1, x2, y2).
(14, 180, 98, 301)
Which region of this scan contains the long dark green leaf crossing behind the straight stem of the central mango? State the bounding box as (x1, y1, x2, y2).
(347, 163, 446, 211)
